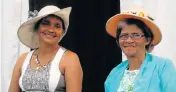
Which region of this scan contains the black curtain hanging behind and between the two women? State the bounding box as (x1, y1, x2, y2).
(29, 0, 122, 92)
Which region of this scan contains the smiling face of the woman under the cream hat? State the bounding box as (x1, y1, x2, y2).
(37, 16, 63, 44)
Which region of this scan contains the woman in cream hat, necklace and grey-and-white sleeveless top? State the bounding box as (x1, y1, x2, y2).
(9, 6, 83, 92)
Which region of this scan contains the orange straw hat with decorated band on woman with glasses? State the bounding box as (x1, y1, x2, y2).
(106, 5, 162, 46)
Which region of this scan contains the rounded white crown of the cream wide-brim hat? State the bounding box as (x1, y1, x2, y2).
(38, 5, 60, 16)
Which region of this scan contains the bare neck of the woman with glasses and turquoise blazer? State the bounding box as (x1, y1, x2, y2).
(127, 54, 145, 70)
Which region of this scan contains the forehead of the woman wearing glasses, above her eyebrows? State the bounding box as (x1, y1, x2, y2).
(121, 24, 142, 33)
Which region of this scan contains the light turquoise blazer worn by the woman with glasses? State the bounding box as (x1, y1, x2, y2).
(105, 53, 176, 92)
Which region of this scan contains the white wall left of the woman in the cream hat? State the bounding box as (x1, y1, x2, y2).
(1, 0, 28, 92)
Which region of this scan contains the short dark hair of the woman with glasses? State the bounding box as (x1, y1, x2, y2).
(116, 18, 153, 51)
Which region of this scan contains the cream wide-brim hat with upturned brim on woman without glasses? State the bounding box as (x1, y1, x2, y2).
(17, 5, 72, 49)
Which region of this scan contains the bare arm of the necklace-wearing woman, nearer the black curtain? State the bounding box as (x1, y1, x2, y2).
(64, 51, 83, 92)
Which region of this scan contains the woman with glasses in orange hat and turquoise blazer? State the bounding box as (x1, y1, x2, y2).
(105, 6, 176, 92)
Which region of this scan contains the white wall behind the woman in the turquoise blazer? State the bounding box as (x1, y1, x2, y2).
(121, 0, 176, 66)
